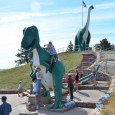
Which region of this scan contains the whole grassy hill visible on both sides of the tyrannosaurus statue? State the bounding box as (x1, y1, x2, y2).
(0, 53, 82, 89)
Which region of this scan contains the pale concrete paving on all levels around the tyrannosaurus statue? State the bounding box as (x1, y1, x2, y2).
(0, 87, 106, 115)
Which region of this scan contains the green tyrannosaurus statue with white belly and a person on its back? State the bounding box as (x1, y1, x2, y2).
(21, 26, 65, 109)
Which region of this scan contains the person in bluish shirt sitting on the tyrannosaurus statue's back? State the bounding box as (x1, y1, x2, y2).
(46, 42, 58, 65)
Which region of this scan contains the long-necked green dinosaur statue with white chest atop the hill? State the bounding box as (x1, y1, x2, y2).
(74, 5, 94, 51)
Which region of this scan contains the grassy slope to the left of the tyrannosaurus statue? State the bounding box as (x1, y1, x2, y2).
(0, 65, 31, 89)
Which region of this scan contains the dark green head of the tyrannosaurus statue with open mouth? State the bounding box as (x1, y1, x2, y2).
(21, 26, 39, 52)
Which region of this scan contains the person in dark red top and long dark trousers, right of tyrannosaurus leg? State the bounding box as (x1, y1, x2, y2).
(68, 74, 74, 101)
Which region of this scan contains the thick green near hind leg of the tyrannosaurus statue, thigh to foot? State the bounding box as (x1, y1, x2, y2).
(52, 61, 65, 109)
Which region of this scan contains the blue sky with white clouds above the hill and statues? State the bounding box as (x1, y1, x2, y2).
(0, 0, 115, 69)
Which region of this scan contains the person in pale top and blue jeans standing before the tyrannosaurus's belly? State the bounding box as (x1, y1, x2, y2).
(36, 67, 43, 96)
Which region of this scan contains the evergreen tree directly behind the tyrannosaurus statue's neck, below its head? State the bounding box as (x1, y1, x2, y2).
(15, 48, 32, 65)
